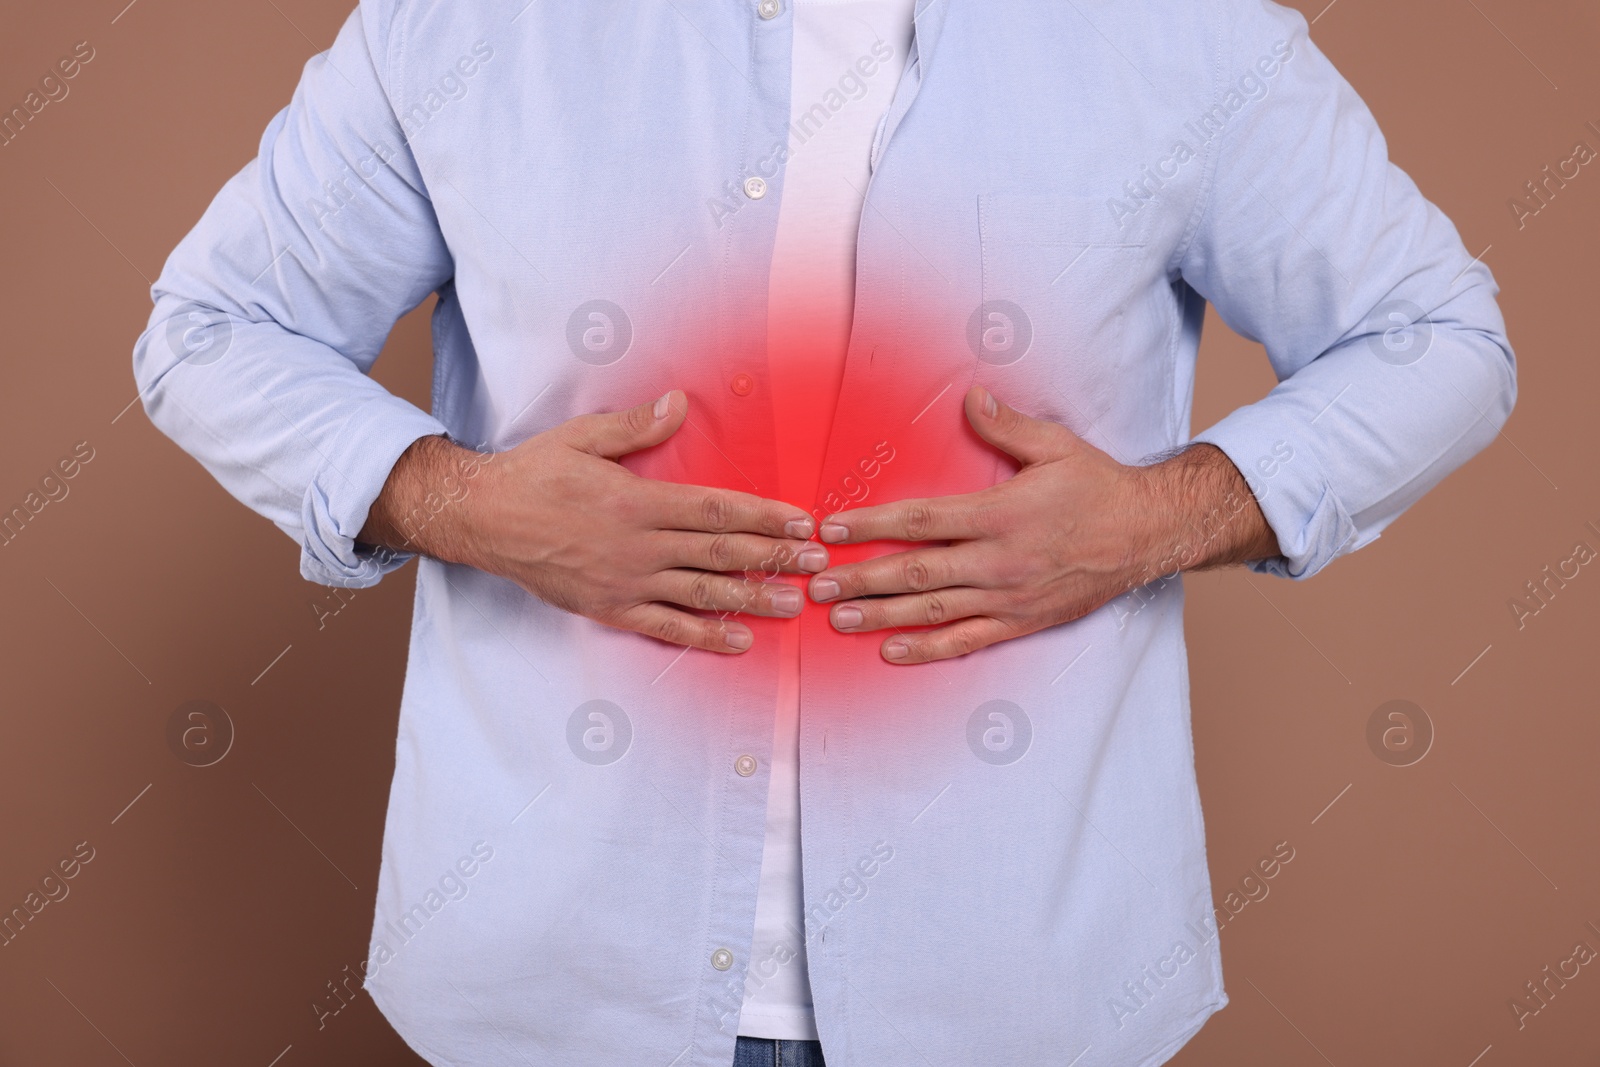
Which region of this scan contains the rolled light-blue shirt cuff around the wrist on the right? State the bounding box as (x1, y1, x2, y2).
(1194, 405, 1371, 579)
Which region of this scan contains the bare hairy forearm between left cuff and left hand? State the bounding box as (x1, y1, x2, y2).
(355, 435, 494, 563)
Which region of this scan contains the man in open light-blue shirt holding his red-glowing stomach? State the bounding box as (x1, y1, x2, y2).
(134, 0, 1515, 1067)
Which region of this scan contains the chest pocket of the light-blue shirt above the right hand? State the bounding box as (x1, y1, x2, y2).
(968, 190, 1181, 462)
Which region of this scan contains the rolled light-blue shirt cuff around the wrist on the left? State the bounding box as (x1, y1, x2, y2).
(301, 395, 446, 589)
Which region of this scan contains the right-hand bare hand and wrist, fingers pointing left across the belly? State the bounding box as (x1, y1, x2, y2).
(811, 386, 1278, 664)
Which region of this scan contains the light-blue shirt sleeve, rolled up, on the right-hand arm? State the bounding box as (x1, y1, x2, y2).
(1179, 0, 1517, 577)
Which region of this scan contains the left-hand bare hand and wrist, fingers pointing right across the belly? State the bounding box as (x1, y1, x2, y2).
(357, 389, 827, 653)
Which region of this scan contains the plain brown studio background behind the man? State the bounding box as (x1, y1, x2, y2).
(0, 0, 1600, 1067)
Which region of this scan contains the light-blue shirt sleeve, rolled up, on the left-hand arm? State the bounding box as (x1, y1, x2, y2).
(133, 0, 453, 587)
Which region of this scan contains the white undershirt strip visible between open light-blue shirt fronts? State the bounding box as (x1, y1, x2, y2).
(739, 0, 915, 1041)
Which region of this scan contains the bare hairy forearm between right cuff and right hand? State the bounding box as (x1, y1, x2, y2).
(1139, 445, 1280, 577)
